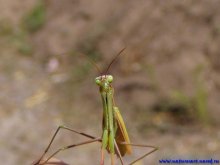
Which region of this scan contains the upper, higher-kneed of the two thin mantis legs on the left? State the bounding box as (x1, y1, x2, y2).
(34, 126, 101, 165)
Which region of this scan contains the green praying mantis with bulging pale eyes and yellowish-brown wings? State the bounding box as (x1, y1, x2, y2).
(33, 48, 158, 165)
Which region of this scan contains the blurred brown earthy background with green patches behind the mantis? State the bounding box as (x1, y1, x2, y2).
(0, 0, 220, 165)
